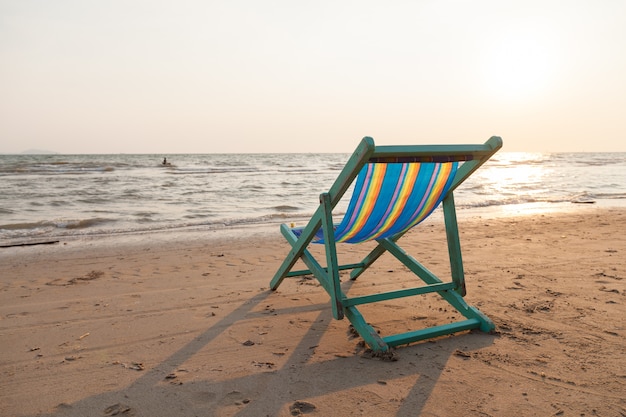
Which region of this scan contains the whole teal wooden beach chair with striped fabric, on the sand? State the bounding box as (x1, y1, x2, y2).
(270, 136, 502, 352)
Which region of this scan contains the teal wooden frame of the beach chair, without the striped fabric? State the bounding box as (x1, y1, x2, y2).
(270, 136, 502, 351)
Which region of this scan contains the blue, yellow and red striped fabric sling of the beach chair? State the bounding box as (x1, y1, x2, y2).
(293, 162, 458, 243)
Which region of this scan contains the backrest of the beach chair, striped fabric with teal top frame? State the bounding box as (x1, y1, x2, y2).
(304, 136, 502, 243)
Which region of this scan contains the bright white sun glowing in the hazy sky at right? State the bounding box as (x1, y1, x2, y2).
(482, 29, 558, 100)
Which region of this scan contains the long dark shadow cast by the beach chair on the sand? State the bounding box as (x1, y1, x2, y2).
(30, 283, 495, 417)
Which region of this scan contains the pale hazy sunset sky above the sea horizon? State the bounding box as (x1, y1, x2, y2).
(0, 0, 626, 154)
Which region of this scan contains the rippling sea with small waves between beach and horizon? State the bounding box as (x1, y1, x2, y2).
(0, 152, 626, 246)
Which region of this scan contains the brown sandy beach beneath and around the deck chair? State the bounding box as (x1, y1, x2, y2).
(0, 205, 626, 417)
